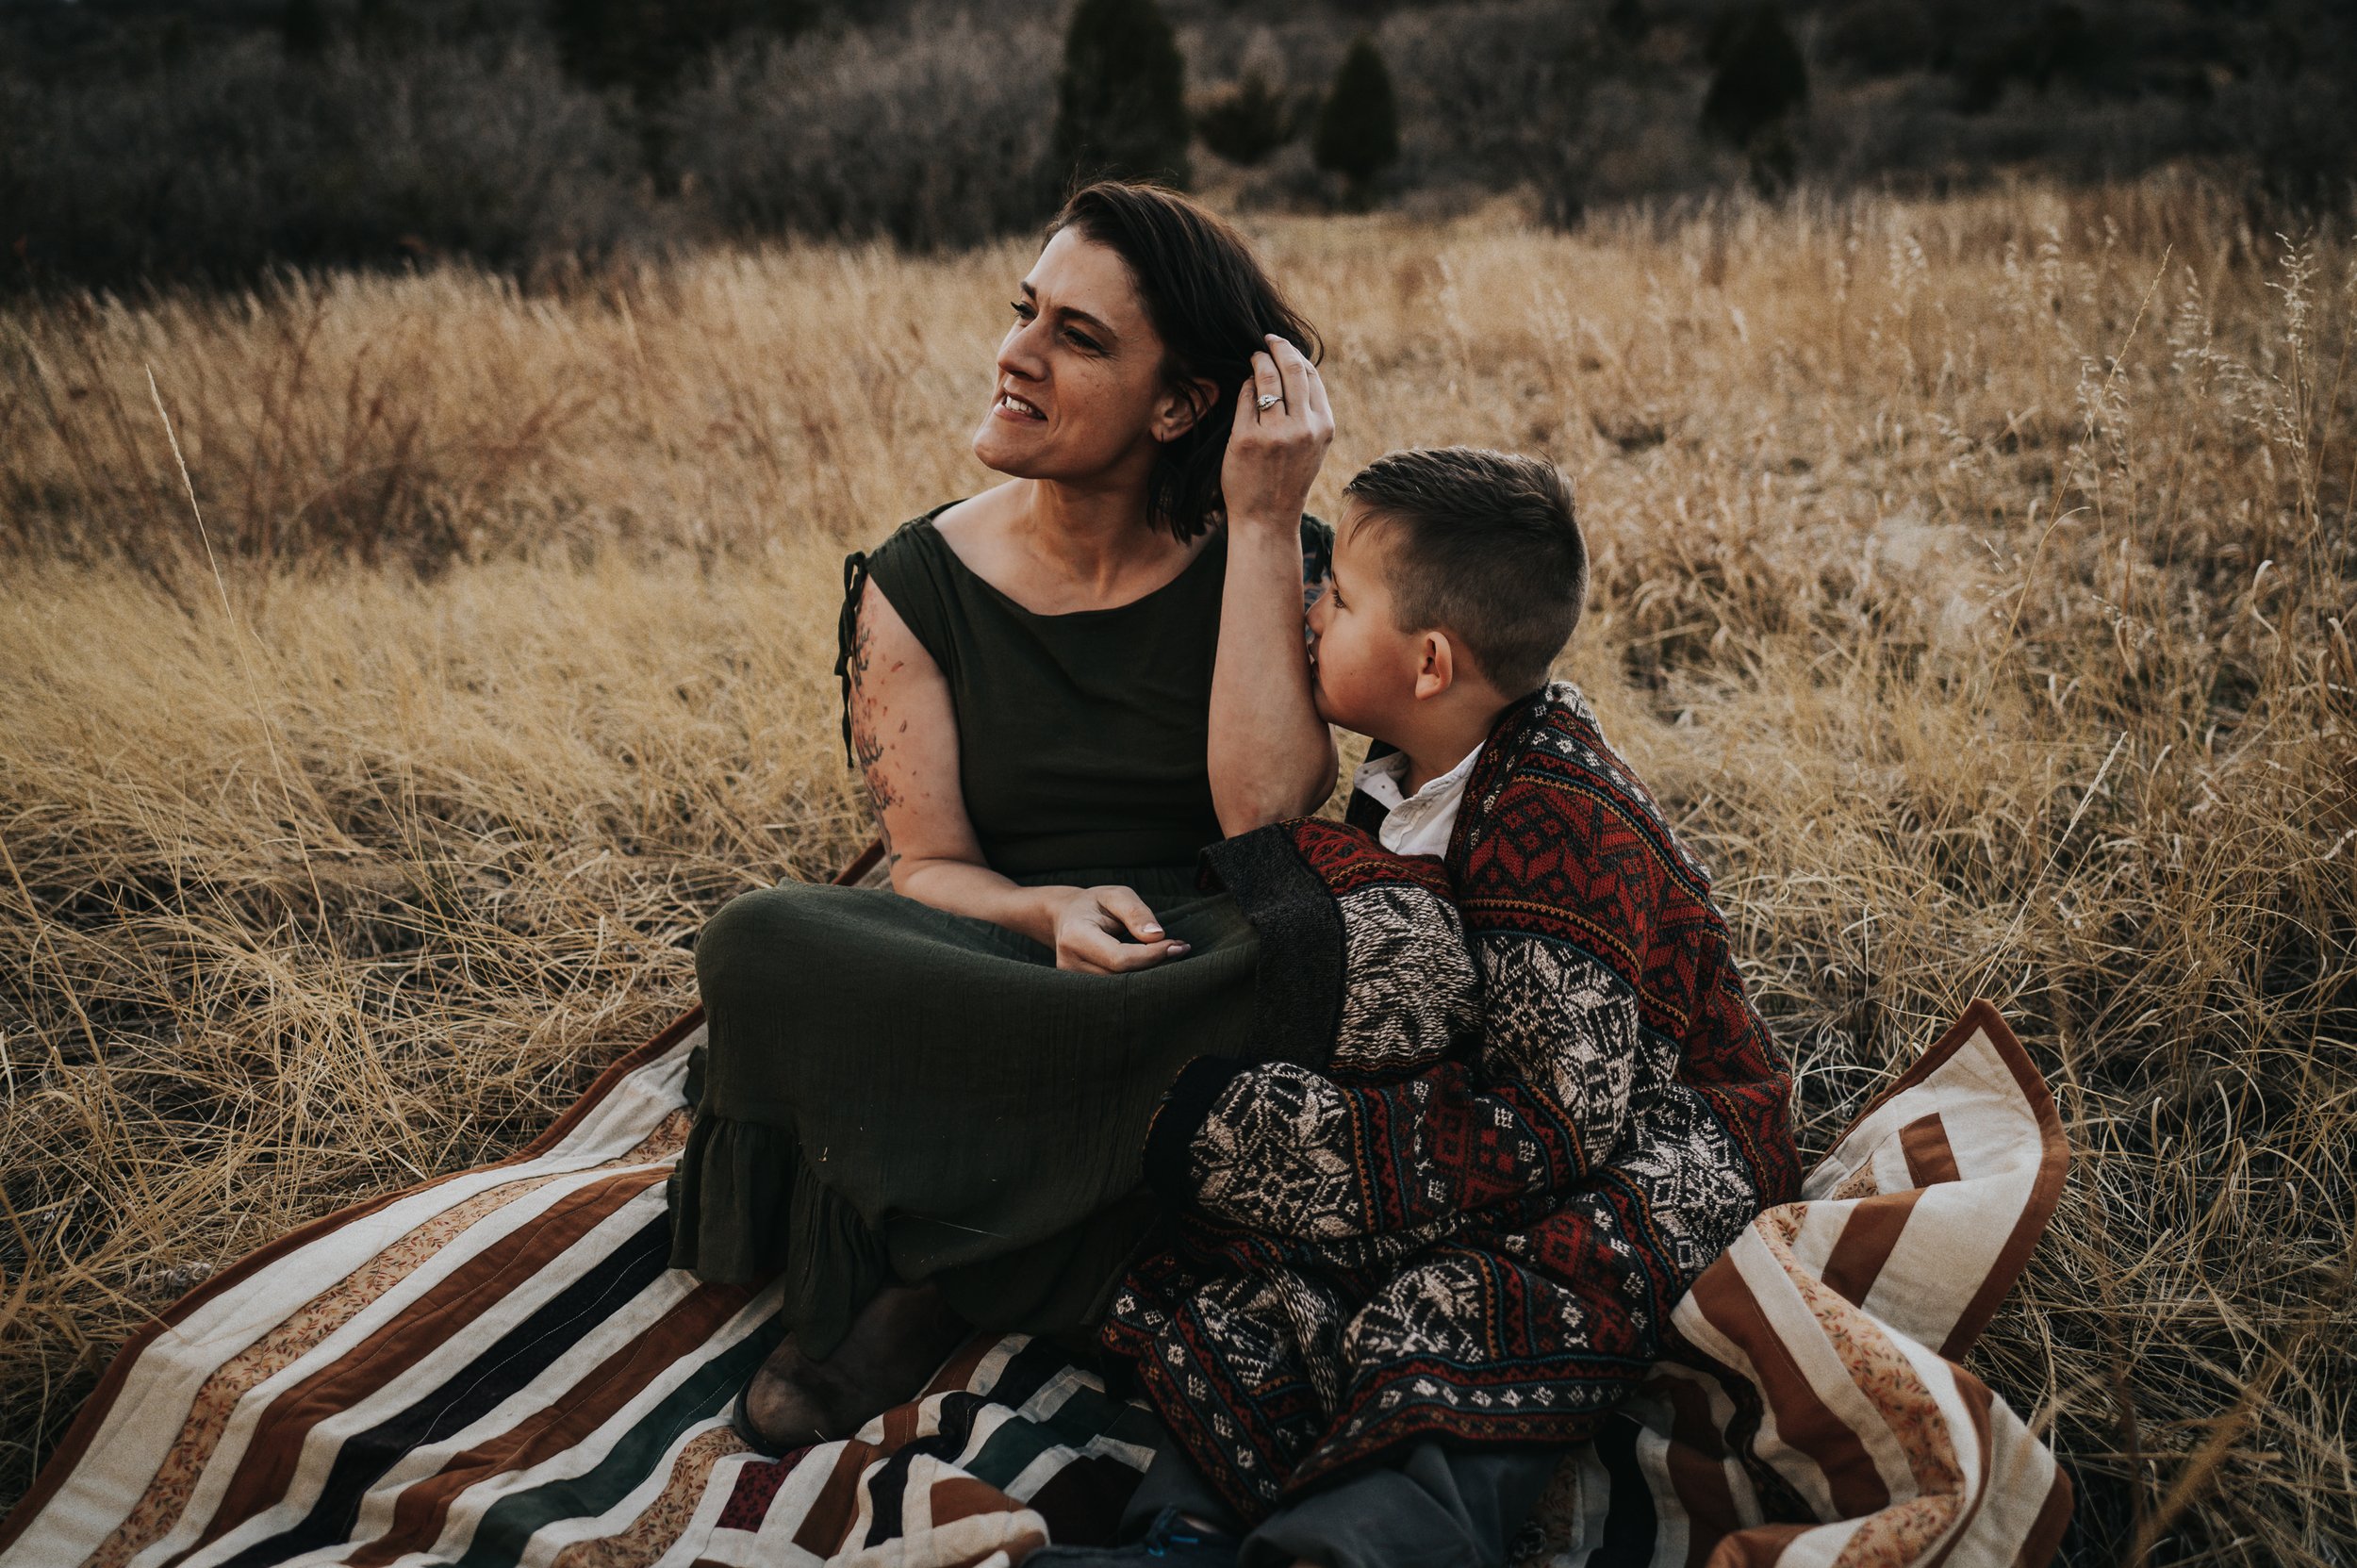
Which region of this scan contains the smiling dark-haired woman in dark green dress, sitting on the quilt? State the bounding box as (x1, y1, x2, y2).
(672, 184, 1337, 1447)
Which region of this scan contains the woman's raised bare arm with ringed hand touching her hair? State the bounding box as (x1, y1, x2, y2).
(1207, 338, 1339, 837)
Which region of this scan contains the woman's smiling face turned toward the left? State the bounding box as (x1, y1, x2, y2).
(974, 229, 1195, 484)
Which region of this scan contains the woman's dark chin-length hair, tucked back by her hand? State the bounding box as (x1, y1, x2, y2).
(1047, 179, 1325, 540)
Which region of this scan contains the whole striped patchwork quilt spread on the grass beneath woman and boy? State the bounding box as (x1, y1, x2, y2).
(0, 1002, 2069, 1568)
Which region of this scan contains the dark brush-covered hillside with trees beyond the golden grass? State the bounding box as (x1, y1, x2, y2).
(0, 0, 2357, 292)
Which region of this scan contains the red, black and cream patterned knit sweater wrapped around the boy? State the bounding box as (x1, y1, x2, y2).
(1103, 684, 1801, 1518)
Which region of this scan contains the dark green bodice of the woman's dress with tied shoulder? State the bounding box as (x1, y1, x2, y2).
(837, 503, 1334, 882)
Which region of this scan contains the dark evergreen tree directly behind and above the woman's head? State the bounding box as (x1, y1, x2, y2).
(1056, 0, 1191, 187)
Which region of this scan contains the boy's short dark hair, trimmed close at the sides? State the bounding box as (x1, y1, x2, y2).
(1343, 446, 1589, 696)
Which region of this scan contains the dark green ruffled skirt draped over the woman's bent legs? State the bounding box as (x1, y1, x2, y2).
(669, 870, 1259, 1356)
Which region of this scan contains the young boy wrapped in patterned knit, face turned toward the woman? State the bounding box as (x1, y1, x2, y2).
(1045, 448, 1799, 1568)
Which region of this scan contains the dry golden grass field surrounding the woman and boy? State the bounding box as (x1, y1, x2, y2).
(0, 182, 2357, 1563)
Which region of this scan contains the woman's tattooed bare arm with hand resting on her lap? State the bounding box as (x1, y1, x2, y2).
(849, 580, 1186, 974)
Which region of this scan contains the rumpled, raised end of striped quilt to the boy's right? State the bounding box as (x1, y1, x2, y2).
(1527, 1002, 2072, 1568)
